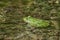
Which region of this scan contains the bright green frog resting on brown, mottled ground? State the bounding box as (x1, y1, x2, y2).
(23, 16, 50, 27)
